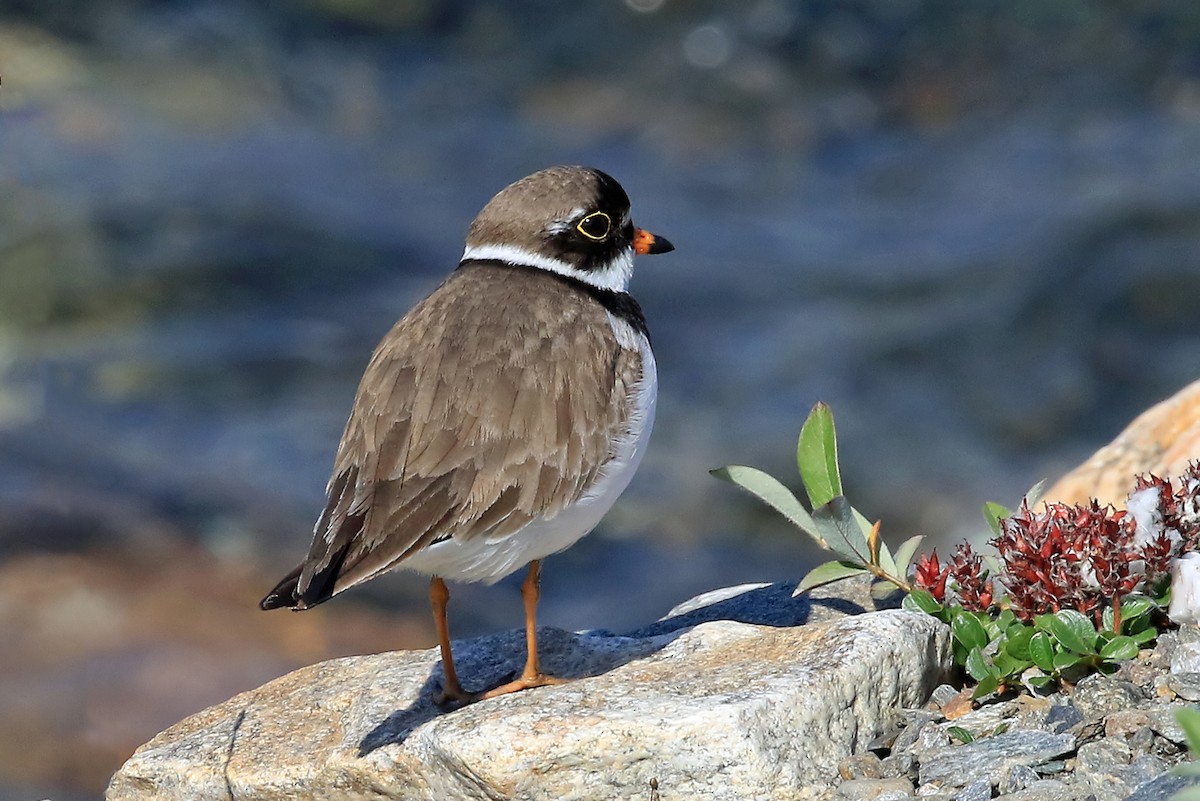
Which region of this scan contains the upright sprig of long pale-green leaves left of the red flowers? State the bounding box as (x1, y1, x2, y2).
(712, 403, 923, 595)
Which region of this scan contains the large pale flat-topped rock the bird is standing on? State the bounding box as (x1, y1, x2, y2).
(107, 610, 949, 801)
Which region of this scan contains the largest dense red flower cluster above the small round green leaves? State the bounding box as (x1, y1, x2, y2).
(992, 500, 1174, 625)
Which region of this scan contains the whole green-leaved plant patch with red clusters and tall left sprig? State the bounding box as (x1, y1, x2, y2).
(713, 403, 1200, 695)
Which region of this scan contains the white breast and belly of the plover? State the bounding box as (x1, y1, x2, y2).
(397, 315, 659, 584)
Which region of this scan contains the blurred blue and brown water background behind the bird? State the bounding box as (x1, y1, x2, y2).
(0, 0, 1200, 801)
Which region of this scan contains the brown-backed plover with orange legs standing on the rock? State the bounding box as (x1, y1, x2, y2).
(259, 165, 674, 707)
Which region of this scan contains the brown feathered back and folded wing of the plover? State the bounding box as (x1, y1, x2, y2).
(280, 266, 641, 606)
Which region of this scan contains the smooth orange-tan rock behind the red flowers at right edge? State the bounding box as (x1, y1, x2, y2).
(1044, 381, 1200, 507)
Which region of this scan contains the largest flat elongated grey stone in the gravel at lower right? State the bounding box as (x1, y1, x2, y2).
(920, 729, 1075, 787)
